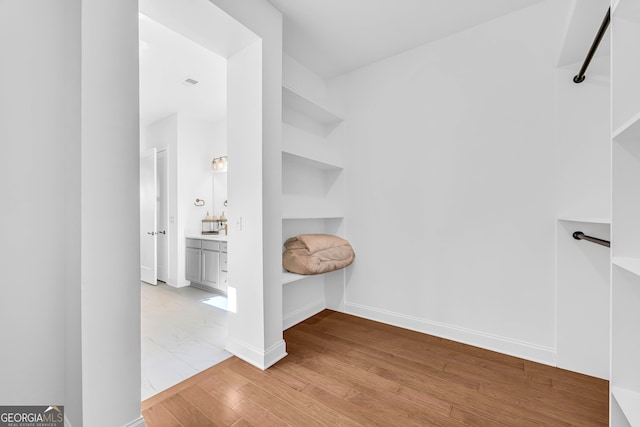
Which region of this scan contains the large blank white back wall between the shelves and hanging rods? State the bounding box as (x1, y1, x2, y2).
(331, 1, 564, 363)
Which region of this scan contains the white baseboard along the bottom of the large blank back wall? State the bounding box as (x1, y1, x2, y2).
(345, 302, 557, 366)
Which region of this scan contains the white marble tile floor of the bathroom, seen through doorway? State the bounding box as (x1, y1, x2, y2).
(140, 282, 231, 400)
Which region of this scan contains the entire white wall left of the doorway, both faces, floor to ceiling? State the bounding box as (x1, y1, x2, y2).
(0, 1, 140, 427)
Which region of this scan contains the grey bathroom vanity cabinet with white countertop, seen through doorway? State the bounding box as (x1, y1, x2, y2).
(185, 235, 227, 293)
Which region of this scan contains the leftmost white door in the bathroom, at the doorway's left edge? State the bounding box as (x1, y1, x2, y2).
(140, 148, 158, 285)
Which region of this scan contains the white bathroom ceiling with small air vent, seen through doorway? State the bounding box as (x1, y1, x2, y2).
(140, 15, 227, 126)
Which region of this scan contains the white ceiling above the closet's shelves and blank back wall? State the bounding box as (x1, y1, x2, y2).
(269, 0, 544, 78)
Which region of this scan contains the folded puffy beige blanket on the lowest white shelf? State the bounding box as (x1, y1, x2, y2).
(282, 234, 356, 274)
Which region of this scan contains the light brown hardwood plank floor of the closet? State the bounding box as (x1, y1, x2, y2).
(142, 310, 609, 427)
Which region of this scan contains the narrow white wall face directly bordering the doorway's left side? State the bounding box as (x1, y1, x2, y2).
(79, 0, 140, 427)
